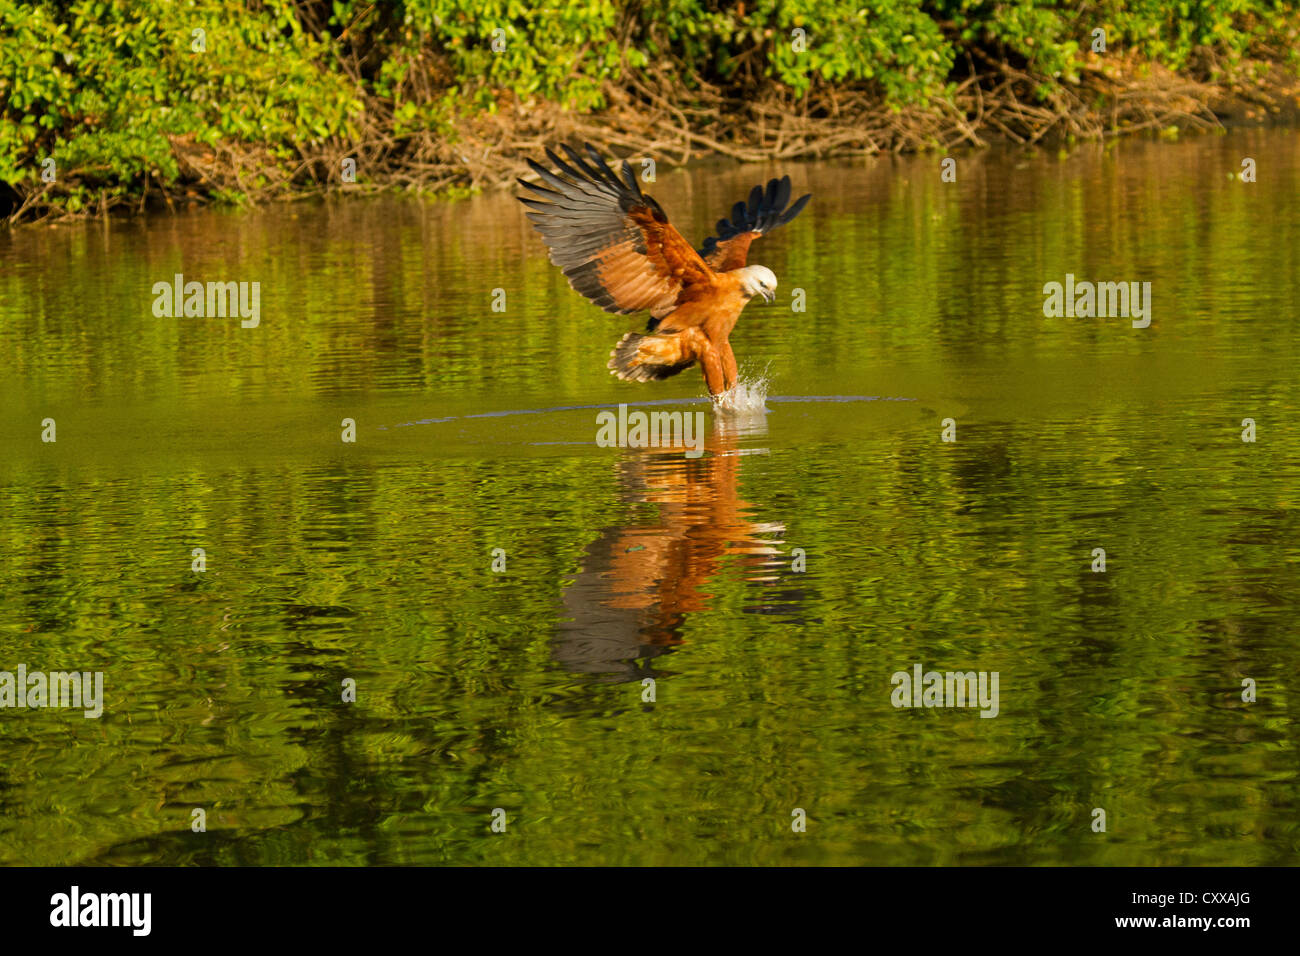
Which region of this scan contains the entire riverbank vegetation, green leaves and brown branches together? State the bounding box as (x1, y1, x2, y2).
(0, 0, 1300, 221)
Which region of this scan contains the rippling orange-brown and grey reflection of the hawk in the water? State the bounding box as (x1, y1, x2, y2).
(554, 414, 785, 682)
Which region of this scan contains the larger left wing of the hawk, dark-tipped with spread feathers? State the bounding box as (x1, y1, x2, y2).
(519, 144, 716, 319)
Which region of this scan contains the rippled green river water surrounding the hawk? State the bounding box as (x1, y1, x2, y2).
(0, 131, 1300, 865)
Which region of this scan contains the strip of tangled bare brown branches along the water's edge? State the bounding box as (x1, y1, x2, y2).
(0, 57, 1300, 230)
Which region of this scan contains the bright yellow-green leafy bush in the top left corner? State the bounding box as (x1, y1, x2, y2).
(0, 0, 360, 211)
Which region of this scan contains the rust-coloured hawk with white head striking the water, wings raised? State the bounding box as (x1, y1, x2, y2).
(519, 144, 811, 395)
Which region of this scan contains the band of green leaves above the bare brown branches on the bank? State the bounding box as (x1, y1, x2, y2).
(0, 0, 1300, 212)
